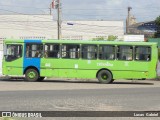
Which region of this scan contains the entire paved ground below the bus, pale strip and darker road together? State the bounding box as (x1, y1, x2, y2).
(0, 80, 160, 120)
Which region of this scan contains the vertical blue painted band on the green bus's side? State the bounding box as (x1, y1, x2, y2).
(23, 40, 42, 73)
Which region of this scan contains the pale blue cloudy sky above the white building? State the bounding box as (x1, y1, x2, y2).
(0, 0, 160, 22)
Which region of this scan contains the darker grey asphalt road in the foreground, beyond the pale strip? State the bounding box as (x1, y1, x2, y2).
(0, 88, 160, 111)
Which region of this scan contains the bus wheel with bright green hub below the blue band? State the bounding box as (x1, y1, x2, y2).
(25, 68, 39, 82)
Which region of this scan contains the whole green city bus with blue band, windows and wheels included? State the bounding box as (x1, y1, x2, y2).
(3, 40, 158, 83)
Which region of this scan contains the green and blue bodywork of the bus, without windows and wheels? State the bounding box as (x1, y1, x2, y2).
(3, 40, 158, 79)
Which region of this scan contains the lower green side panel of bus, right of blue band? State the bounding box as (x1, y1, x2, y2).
(41, 58, 156, 79)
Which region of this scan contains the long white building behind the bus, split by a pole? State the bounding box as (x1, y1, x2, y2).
(0, 15, 124, 40)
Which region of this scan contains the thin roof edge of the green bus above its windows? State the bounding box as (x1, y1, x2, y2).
(4, 39, 157, 45)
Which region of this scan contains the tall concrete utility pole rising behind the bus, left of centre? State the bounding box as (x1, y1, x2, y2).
(52, 0, 62, 40)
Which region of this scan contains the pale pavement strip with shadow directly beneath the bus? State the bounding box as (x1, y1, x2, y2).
(0, 79, 160, 91)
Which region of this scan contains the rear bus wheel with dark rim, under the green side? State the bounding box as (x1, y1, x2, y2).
(97, 70, 113, 84)
